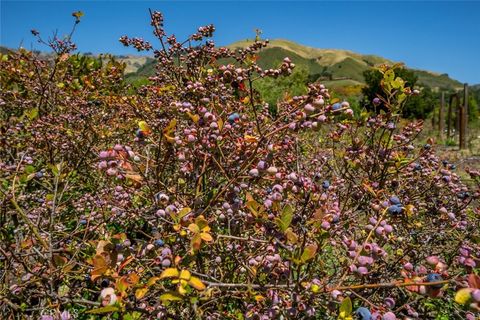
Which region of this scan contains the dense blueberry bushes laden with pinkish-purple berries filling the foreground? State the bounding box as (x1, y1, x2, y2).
(0, 12, 480, 320)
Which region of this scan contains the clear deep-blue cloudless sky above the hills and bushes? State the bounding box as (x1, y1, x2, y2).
(0, 0, 480, 83)
